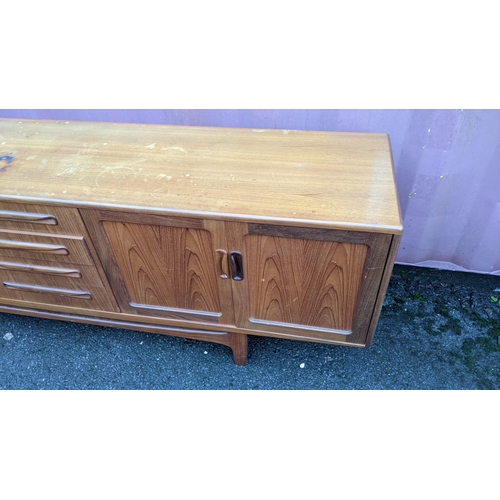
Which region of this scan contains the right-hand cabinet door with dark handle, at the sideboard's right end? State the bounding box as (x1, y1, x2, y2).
(227, 223, 392, 345)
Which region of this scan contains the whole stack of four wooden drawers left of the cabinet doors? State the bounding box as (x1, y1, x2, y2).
(0, 202, 118, 311)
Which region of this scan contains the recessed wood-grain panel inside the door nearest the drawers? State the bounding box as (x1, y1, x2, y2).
(103, 221, 221, 312)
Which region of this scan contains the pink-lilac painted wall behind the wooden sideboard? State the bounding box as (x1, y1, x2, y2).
(0, 110, 500, 275)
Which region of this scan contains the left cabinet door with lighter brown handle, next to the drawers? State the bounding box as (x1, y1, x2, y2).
(81, 209, 234, 325)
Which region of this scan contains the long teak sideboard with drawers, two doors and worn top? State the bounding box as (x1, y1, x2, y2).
(0, 119, 403, 365)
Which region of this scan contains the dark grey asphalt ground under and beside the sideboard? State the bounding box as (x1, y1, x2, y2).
(0, 266, 500, 390)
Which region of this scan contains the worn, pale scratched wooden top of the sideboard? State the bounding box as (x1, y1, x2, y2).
(0, 119, 403, 234)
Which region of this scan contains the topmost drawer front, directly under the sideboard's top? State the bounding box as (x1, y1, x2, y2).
(0, 201, 86, 236)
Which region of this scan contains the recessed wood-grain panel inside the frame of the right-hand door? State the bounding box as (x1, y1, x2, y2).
(245, 235, 367, 331)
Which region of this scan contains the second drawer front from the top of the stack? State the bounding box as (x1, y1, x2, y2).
(0, 230, 93, 265)
